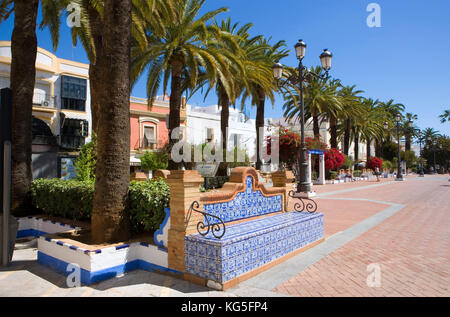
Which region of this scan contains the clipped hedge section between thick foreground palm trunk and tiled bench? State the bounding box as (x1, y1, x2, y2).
(128, 178, 170, 232)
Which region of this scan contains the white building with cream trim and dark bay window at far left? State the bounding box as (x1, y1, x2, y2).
(0, 41, 92, 178)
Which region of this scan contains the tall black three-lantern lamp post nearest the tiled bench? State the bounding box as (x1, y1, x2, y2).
(273, 40, 333, 198)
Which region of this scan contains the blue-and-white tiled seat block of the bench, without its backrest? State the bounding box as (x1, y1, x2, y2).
(185, 212, 324, 284)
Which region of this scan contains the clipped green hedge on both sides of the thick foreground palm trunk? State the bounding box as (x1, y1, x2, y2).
(31, 178, 170, 233)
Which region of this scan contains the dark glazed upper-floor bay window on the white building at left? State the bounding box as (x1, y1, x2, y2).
(61, 76, 87, 111)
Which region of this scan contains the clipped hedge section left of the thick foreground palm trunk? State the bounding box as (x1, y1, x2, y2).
(31, 179, 94, 220)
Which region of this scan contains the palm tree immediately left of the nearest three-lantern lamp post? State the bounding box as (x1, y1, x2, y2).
(242, 38, 289, 170)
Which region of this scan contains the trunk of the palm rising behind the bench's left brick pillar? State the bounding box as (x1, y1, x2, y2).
(169, 60, 183, 170)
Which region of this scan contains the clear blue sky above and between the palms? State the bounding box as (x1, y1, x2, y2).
(0, 0, 450, 135)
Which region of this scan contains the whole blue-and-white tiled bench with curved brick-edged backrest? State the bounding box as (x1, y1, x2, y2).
(184, 169, 324, 289)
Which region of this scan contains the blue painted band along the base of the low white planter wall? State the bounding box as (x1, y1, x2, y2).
(38, 251, 183, 285)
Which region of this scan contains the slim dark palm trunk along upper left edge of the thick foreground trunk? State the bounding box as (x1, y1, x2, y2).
(87, 5, 103, 133)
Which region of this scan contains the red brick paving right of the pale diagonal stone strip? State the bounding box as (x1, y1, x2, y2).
(274, 176, 450, 296)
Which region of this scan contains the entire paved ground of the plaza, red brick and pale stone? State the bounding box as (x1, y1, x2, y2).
(0, 175, 450, 297)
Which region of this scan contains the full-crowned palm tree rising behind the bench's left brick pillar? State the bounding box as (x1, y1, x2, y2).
(131, 0, 230, 169)
